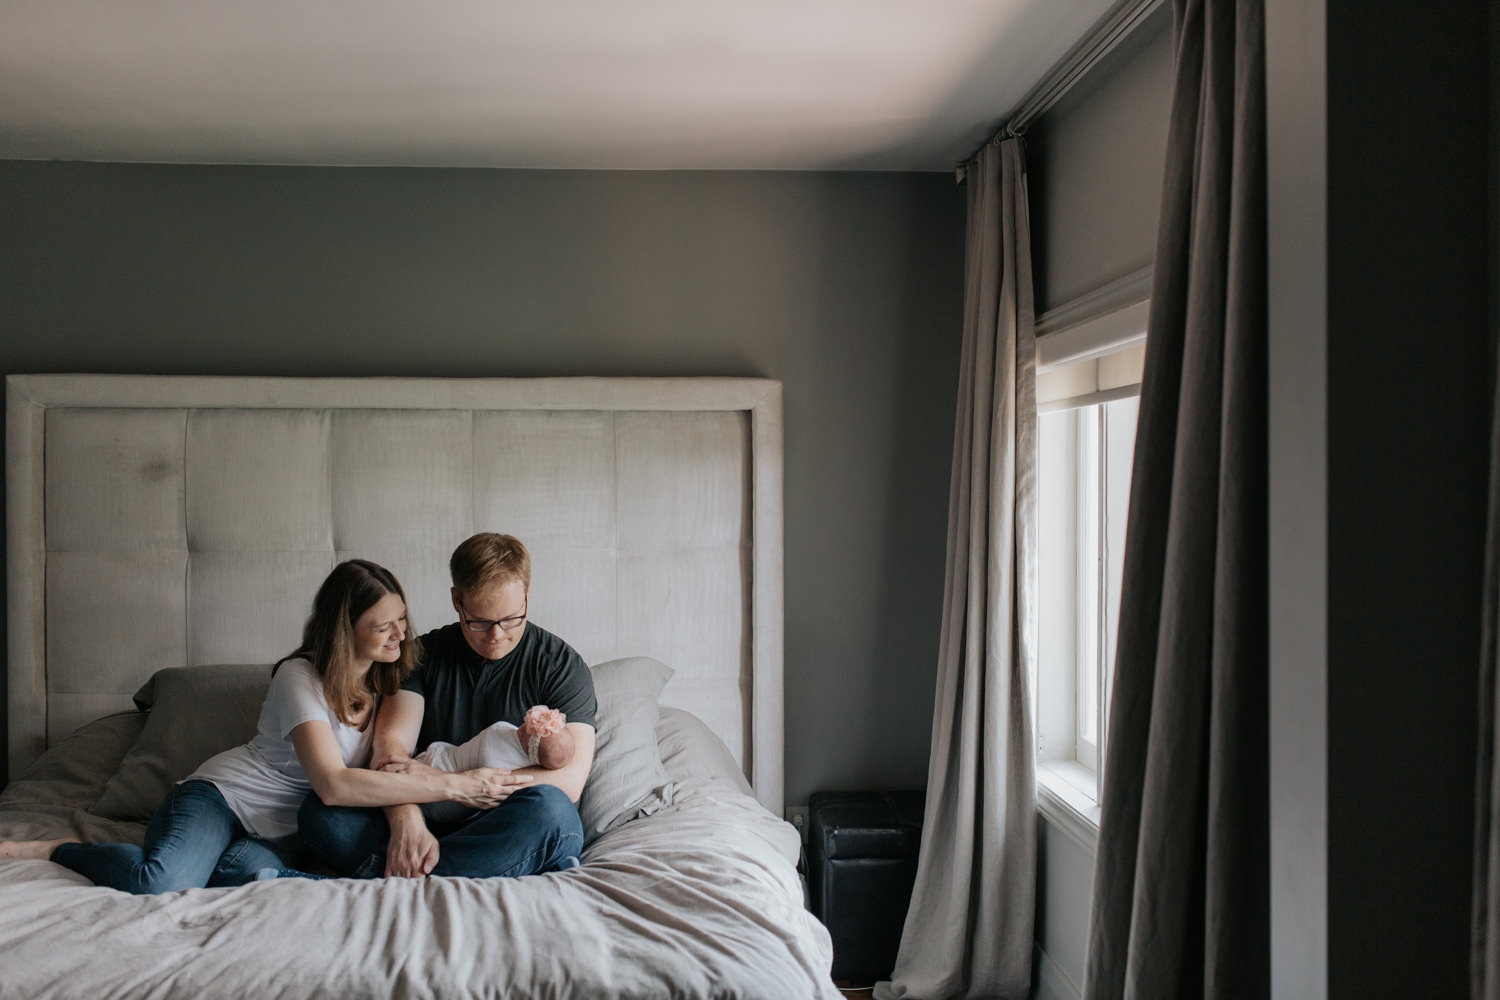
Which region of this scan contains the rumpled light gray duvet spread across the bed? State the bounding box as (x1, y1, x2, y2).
(0, 717, 840, 1000)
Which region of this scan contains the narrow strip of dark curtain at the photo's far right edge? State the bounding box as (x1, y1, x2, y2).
(1469, 260, 1500, 1000)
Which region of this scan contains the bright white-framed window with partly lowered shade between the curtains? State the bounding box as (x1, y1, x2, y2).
(1034, 293, 1146, 846)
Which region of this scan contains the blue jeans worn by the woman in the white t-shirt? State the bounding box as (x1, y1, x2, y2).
(53, 780, 288, 894)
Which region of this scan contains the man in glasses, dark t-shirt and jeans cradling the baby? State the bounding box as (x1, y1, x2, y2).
(299, 532, 596, 877)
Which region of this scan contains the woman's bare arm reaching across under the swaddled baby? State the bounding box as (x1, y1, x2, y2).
(291, 720, 531, 810)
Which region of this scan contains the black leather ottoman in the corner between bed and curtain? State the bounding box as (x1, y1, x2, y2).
(807, 792, 926, 987)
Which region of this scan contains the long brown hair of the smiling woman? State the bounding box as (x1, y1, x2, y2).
(272, 559, 422, 729)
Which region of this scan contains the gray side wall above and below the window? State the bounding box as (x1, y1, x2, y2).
(1026, 6, 1172, 997)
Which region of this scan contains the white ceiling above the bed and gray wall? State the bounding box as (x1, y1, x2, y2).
(0, 0, 1113, 169)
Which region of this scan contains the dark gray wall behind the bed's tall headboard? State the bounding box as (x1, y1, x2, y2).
(0, 162, 963, 804)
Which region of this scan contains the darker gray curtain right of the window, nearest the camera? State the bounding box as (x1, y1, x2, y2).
(1085, 0, 1271, 1000)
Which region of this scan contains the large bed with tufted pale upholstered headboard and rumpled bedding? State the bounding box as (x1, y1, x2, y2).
(0, 375, 840, 1000)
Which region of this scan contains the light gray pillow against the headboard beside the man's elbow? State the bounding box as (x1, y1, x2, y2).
(578, 657, 677, 844)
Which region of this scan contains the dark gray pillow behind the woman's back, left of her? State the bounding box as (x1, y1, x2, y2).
(93, 663, 272, 820)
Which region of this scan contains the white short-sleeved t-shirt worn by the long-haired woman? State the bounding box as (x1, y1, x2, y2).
(188, 660, 375, 840)
